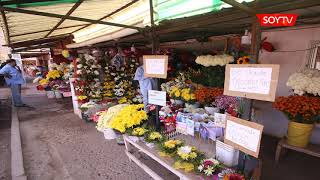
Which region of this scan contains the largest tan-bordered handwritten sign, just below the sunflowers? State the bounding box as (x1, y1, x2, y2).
(224, 64, 280, 101)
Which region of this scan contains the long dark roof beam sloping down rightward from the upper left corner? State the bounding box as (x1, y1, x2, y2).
(0, 6, 142, 30)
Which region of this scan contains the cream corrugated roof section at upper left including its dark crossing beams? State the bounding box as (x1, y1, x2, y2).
(0, 0, 138, 47)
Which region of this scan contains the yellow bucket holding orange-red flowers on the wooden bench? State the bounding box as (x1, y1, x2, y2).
(287, 121, 314, 148)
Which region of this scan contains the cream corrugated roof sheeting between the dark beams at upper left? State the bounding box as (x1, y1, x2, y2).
(1, 0, 132, 44)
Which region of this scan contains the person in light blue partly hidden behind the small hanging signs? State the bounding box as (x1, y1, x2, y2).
(133, 57, 156, 111)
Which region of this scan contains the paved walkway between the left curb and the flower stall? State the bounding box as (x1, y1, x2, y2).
(19, 84, 150, 180)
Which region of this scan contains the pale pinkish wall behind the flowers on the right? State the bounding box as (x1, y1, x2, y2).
(255, 25, 320, 144)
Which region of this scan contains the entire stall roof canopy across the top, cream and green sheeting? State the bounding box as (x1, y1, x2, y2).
(0, 0, 320, 49)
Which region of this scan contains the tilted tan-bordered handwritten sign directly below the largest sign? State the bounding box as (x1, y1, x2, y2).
(224, 116, 263, 158)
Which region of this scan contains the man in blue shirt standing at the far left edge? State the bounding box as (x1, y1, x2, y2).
(0, 59, 26, 107)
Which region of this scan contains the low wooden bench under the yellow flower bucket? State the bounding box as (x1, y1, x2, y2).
(275, 138, 320, 163)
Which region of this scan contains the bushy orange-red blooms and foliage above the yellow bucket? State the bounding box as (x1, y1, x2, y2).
(273, 95, 320, 124)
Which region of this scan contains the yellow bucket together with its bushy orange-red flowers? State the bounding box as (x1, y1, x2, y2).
(273, 95, 320, 147)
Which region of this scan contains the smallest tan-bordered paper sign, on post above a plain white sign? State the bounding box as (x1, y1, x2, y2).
(143, 55, 168, 79)
